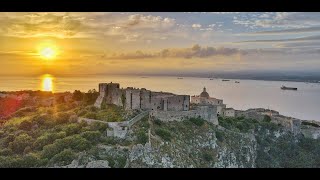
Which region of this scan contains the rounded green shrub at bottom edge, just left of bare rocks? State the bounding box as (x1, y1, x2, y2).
(50, 149, 77, 166)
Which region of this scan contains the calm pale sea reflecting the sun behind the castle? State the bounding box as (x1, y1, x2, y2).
(0, 75, 320, 120)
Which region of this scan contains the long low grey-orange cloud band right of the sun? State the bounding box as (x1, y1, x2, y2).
(106, 44, 246, 59)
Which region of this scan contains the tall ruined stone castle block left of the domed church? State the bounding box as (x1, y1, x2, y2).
(95, 82, 190, 111)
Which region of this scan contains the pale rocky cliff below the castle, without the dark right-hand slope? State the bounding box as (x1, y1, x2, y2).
(65, 121, 257, 168)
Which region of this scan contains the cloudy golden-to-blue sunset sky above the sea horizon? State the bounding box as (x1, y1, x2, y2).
(0, 12, 320, 76)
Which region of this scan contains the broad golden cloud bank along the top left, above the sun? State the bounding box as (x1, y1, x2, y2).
(0, 13, 176, 41)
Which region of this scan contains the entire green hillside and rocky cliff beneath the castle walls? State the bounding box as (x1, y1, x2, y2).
(0, 102, 320, 168)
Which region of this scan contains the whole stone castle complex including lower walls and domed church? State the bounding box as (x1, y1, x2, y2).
(94, 82, 234, 124)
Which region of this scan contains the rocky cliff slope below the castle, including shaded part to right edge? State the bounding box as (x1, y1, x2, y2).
(57, 115, 320, 168)
